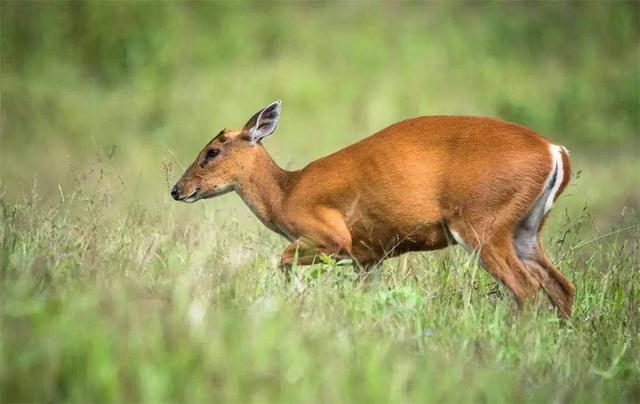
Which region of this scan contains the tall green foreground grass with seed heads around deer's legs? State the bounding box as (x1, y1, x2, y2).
(0, 163, 640, 402)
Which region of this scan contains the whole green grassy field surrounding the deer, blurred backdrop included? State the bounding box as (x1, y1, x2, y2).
(0, 1, 640, 402)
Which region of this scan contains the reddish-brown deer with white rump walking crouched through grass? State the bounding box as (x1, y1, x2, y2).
(171, 100, 574, 319)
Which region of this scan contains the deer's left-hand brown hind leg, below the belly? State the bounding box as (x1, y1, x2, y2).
(451, 225, 540, 309)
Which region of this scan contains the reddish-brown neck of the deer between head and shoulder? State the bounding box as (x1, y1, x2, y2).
(235, 145, 296, 238)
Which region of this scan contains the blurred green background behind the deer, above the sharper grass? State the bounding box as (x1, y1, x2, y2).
(0, 1, 640, 221)
